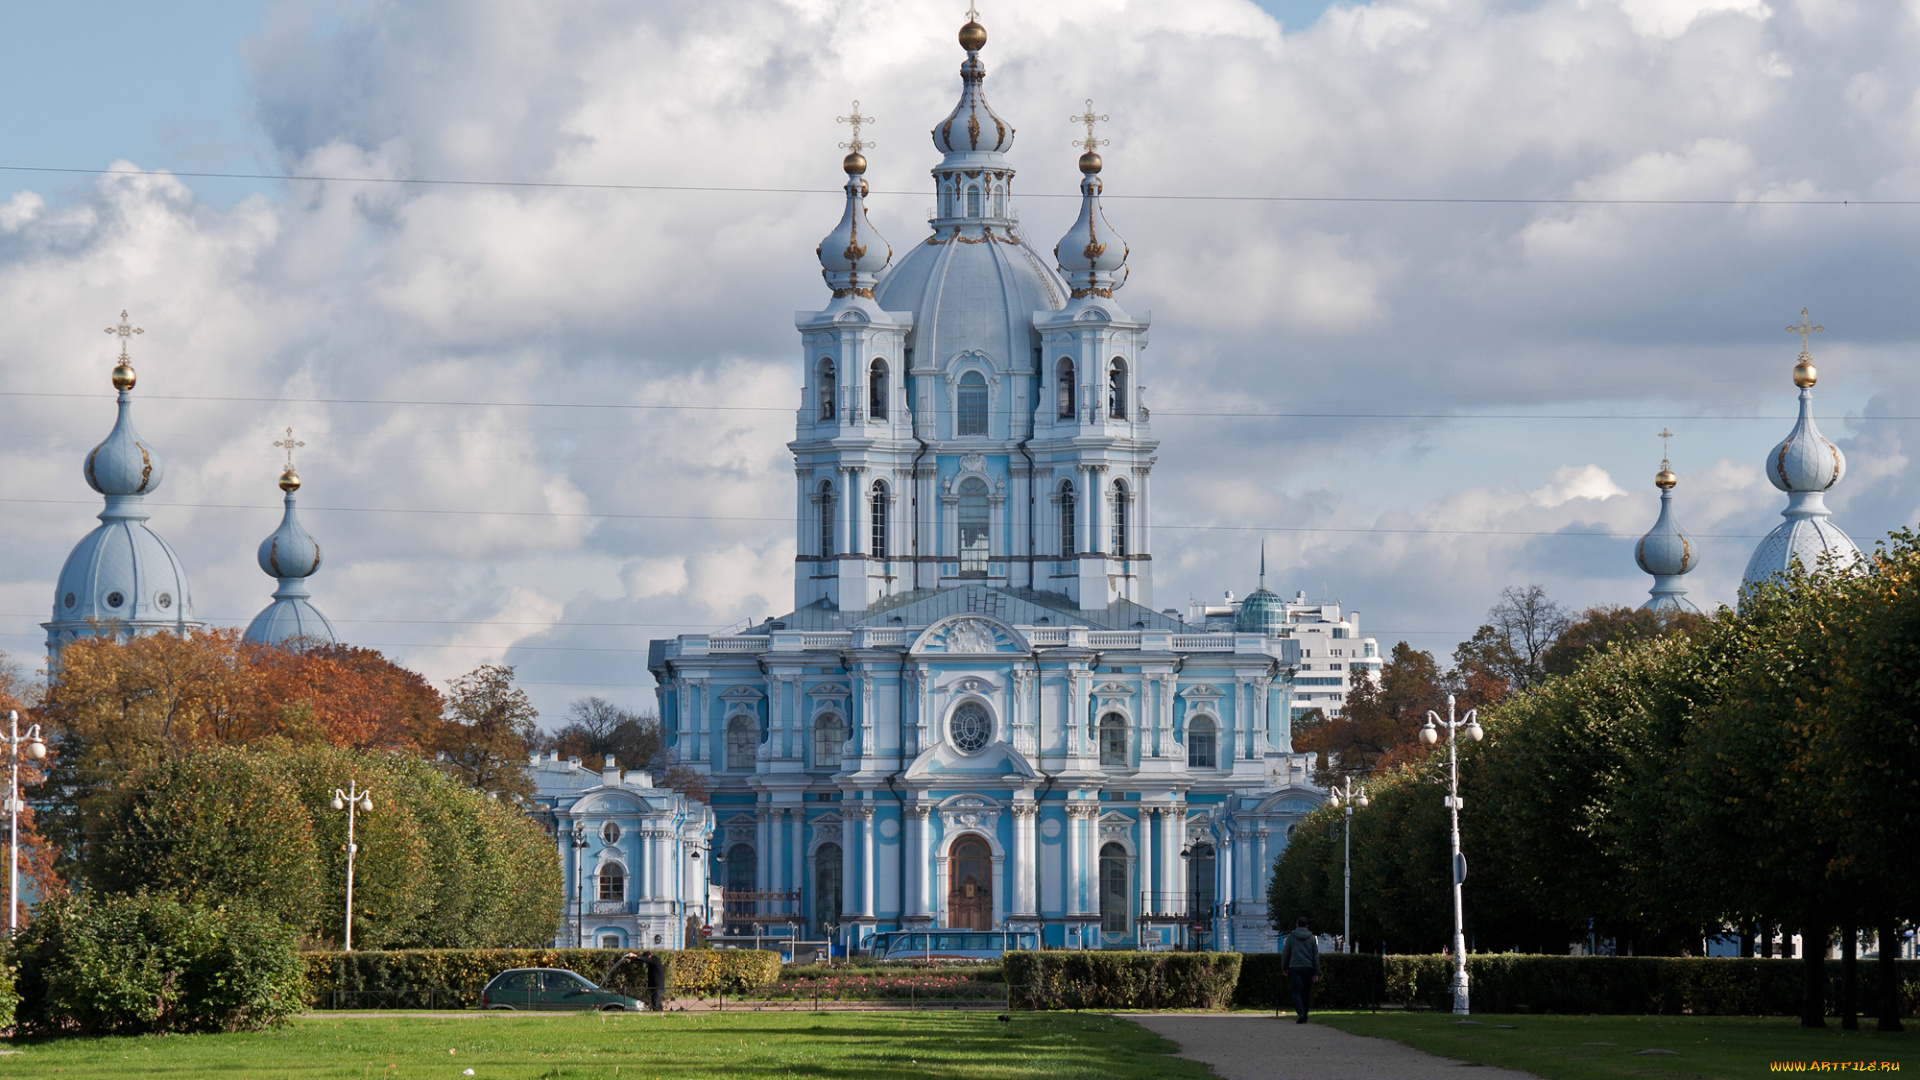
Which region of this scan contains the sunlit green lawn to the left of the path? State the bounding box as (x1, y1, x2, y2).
(0, 1013, 1212, 1080)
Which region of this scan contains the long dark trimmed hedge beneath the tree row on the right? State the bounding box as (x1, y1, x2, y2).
(1233, 953, 1920, 1017)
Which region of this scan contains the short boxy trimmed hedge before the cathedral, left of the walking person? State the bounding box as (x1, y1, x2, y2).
(1002, 951, 1240, 1009)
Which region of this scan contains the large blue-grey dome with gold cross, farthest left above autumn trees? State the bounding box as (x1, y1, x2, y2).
(42, 311, 200, 667)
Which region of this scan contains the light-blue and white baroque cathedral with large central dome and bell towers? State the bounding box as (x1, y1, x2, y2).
(649, 12, 1380, 949)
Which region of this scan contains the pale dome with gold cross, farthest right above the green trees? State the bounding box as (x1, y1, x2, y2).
(1743, 311, 1860, 584)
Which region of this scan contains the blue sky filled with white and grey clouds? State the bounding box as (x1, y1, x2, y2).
(0, 0, 1920, 715)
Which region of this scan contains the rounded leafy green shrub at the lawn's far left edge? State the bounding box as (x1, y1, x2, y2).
(15, 894, 305, 1034)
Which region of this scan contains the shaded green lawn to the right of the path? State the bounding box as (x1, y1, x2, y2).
(1313, 1013, 1920, 1080)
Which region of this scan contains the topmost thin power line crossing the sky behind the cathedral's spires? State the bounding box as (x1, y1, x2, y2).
(0, 165, 1920, 206)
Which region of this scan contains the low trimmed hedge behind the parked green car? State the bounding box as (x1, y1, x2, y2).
(301, 949, 780, 1009)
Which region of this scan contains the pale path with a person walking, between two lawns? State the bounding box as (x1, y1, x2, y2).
(1125, 1013, 1538, 1080)
